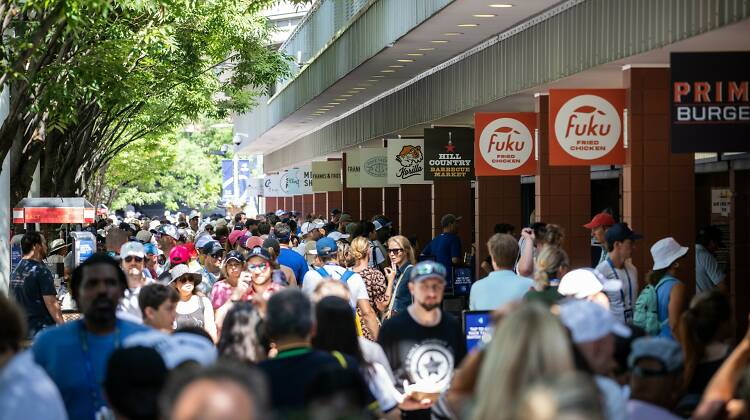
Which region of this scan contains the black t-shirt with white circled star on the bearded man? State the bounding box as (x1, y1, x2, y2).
(378, 311, 466, 419)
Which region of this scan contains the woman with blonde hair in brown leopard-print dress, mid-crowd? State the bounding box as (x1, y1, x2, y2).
(349, 236, 393, 341)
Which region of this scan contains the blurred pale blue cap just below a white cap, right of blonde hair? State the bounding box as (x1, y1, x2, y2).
(560, 299, 631, 344)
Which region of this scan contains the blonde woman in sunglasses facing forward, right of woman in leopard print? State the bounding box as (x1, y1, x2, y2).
(385, 235, 417, 318)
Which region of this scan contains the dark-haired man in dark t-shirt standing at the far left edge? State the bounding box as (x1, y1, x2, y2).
(10, 231, 63, 339)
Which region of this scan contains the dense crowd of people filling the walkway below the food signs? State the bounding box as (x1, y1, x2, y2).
(0, 210, 750, 420)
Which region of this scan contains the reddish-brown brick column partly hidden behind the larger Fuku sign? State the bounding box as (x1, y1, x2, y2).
(535, 95, 591, 267)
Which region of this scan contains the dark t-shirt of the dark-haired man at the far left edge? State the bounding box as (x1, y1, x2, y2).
(10, 259, 57, 336)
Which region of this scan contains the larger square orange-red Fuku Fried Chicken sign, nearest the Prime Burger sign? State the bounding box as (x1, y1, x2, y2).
(549, 89, 625, 166)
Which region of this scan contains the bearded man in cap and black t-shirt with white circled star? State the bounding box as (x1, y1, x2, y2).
(378, 261, 466, 419)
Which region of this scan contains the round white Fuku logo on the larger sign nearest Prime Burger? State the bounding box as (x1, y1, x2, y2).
(554, 95, 622, 160)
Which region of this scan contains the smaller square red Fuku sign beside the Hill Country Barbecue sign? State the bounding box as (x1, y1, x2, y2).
(474, 112, 536, 176)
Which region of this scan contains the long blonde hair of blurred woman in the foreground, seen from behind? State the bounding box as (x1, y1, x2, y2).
(472, 302, 576, 420)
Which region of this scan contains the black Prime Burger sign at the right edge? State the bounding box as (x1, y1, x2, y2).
(670, 52, 750, 153)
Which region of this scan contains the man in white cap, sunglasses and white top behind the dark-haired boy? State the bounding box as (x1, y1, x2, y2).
(117, 241, 153, 323)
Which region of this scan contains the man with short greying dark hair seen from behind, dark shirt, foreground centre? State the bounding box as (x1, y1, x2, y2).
(258, 288, 378, 418)
